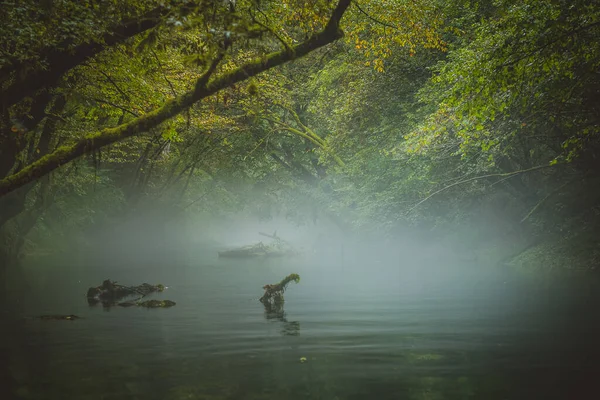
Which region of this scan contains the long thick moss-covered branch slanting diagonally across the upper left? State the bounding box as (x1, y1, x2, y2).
(0, 0, 351, 196)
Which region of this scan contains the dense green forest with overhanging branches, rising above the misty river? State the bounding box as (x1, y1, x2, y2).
(0, 0, 600, 271)
